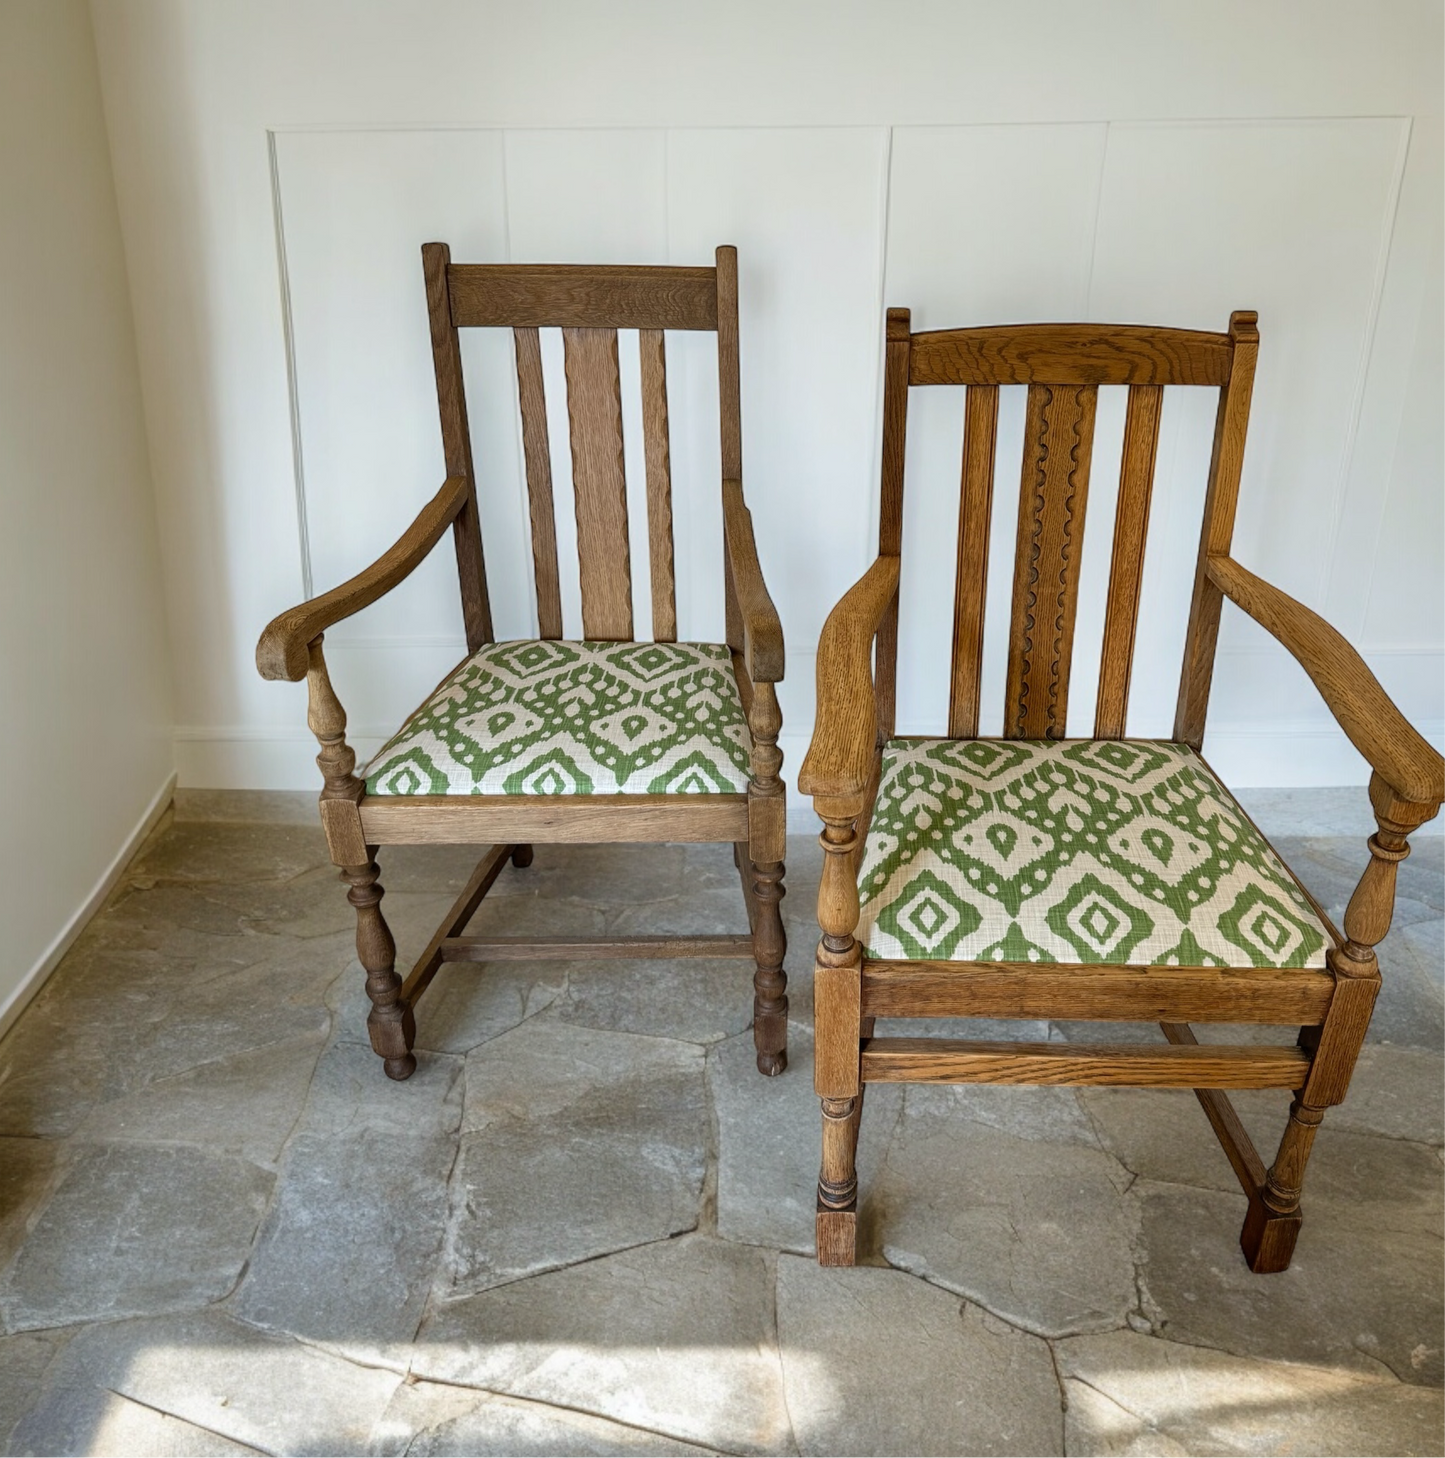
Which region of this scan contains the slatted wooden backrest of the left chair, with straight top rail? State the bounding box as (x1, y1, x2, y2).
(421, 243, 742, 650)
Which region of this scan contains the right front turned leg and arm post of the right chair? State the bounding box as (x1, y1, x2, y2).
(1241, 774, 1439, 1273)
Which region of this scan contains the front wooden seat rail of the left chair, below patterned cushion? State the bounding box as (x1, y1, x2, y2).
(362, 795, 748, 846)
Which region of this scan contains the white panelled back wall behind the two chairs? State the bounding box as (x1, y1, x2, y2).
(93, 0, 1445, 810)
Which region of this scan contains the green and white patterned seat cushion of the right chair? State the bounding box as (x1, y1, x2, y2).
(857, 739, 1328, 967)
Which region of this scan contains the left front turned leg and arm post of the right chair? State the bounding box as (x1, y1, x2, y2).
(814, 812, 863, 1266)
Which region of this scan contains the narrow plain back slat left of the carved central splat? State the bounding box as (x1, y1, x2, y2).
(948, 385, 999, 739)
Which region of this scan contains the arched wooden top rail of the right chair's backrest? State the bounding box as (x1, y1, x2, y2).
(908, 324, 1231, 385)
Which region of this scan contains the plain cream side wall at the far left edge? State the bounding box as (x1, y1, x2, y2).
(0, 0, 172, 1026)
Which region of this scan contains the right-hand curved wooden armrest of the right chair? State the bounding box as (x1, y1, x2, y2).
(1206, 557, 1445, 805)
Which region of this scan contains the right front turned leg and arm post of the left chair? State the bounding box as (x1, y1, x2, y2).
(744, 684, 787, 1076)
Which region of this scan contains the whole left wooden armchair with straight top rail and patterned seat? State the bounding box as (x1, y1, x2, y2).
(257, 243, 787, 1079)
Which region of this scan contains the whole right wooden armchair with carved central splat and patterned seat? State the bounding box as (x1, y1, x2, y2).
(799, 309, 1445, 1271)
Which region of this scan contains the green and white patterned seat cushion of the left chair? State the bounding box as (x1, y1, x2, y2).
(366, 640, 751, 795)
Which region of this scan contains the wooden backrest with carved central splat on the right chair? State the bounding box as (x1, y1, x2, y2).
(876, 309, 1258, 748)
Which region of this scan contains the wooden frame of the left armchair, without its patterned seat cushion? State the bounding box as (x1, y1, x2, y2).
(257, 243, 787, 1079)
